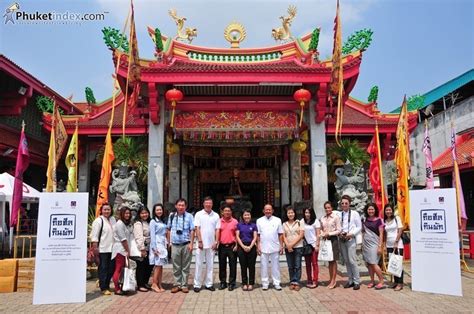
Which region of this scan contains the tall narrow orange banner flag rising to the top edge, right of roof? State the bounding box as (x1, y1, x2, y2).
(329, 0, 344, 145)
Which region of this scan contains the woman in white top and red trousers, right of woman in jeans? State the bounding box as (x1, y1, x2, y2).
(301, 208, 321, 289)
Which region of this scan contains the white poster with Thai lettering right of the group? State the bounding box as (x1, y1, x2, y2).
(410, 189, 462, 296)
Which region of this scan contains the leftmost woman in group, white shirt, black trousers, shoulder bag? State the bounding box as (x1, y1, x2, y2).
(90, 203, 116, 295)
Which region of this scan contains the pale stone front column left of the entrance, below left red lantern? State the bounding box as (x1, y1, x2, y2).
(147, 99, 165, 208)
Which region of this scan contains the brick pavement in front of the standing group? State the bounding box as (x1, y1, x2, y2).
(0, 263, 474, 314)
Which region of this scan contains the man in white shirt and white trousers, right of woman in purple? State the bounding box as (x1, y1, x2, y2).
(257, 204, 283, 291)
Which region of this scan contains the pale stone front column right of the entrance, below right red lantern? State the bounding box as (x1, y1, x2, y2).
(309, 100, 329, 218)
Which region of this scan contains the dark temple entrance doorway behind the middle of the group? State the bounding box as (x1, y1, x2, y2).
(182, 145, 287, 219)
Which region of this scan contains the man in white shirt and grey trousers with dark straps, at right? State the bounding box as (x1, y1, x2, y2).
(339, 195, 362, 290)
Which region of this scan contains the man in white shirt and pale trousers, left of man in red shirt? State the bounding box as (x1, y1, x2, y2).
(194, 196, 220, 292)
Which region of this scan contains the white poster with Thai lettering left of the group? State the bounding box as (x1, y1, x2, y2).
(33, 193, 89, 304)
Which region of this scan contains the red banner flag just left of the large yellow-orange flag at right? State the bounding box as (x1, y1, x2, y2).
(367, 127, 388, 217)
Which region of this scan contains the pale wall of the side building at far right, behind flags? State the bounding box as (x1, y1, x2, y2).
(410, 96, 474, 185)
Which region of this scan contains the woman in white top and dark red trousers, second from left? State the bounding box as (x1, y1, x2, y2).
(112, 207, 133, 295)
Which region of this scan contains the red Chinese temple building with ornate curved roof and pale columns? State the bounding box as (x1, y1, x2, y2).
(0, 7, 417, 217)
